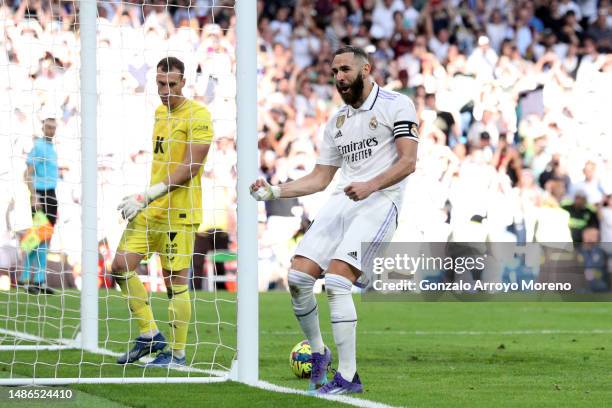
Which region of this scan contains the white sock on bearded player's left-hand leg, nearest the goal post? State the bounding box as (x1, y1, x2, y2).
(288, 269, 325, 353)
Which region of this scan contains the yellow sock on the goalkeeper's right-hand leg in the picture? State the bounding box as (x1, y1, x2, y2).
(168, 285, 191, 357)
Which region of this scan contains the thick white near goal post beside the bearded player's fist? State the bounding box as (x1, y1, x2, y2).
(235, 0, 259, 384)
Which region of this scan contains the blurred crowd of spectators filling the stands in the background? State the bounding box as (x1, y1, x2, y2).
(0, 0, 612, 289)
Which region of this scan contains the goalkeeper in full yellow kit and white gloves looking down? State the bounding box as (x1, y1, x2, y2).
(112, 57, 213, 367)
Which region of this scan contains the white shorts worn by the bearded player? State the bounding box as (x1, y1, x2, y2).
(295, 191, 397, 271)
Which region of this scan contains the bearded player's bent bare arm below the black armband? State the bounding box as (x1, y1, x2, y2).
(344, 138, 419, 201)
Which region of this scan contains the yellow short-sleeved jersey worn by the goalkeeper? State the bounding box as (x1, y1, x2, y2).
(144, 99, 213, 225)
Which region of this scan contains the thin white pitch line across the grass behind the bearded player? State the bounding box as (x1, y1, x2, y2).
(260, 329, 612, 336)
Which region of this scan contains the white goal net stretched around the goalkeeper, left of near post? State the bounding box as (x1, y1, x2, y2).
(0, 0, 256, 384)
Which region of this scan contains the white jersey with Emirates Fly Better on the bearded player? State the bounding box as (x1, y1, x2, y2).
(317, 84, 419, 210)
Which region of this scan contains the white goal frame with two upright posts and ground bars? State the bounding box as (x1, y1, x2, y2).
(0, 0, 259, 386)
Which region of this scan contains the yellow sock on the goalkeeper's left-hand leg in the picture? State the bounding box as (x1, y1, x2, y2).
(117, 271, 159, 337)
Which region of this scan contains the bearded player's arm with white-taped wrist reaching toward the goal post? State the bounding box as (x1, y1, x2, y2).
(251, 164, 338, 201)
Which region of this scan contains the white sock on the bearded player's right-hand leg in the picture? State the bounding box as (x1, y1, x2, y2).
(325, 274, 357, 381)
